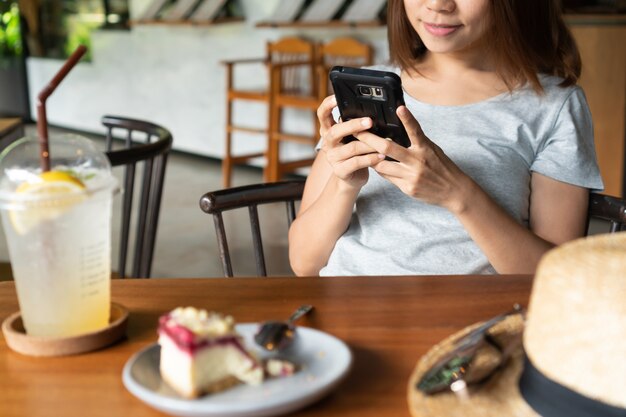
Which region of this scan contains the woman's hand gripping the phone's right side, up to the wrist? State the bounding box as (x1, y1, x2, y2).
(356, 106, 473, 213)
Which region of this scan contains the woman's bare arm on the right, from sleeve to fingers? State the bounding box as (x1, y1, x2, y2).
(358, 107, 588, 273)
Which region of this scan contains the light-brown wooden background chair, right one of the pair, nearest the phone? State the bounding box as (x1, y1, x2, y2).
(265, 38, 372, 182)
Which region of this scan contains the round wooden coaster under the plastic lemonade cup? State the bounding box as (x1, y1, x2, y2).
(2, 303, 128, 356)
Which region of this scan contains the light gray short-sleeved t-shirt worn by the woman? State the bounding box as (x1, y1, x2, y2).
(320, 66, 603, 276)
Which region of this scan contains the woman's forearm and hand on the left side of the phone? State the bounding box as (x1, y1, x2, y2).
(289, 96, 383, 276)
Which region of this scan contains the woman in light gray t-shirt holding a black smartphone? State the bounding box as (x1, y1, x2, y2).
(289, 0, 603, 275)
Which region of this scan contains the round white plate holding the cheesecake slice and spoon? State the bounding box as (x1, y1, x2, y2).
(122, 323, 352, 417)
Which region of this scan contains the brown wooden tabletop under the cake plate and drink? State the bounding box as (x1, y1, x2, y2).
(0, 275, 532, 417)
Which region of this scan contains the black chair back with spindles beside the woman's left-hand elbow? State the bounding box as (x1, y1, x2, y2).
(200, 180, 304, 277)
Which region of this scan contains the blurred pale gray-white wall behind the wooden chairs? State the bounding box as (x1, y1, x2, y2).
(27, 0, 388, 158)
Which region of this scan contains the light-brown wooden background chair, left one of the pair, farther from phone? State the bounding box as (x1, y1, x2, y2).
(222, 37, 316, 188)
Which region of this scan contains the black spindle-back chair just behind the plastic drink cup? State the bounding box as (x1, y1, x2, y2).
(102, 116, 172, 278)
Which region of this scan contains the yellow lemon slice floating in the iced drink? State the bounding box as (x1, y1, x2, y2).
(9, 171, 86, 235)
